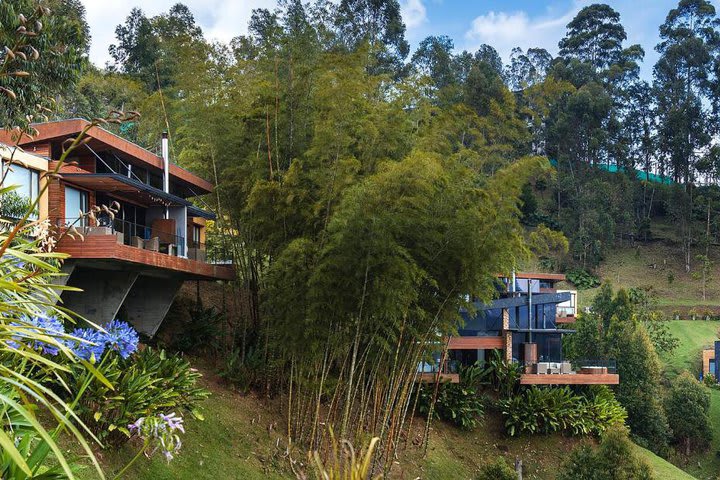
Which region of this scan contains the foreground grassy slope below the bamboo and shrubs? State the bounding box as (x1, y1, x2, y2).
(71, 362, 692, 480)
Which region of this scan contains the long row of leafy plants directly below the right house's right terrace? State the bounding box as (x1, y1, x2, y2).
(498, 386, 627, 436)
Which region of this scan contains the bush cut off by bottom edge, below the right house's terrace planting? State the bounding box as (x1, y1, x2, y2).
(557, 427, 654, 480)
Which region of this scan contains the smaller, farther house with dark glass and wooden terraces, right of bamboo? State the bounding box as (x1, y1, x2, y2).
(422, 273, 620, 385)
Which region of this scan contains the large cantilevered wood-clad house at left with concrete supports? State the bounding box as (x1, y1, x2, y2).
(0, 119, 234, 336)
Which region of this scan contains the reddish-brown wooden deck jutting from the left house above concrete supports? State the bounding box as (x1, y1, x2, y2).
(56, 235, 235, 280)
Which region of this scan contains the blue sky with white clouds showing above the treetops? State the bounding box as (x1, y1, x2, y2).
(83, 0, 720, 78)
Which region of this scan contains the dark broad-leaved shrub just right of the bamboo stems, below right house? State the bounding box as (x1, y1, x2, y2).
(418, 365, 486, 430)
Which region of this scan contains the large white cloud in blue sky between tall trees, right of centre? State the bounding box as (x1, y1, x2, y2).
(465, 2, 580, 60)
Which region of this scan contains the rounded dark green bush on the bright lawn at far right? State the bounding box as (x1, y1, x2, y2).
(665, 371, 712, 455)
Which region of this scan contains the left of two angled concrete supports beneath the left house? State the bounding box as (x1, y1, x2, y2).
(61, 267, 138, 325)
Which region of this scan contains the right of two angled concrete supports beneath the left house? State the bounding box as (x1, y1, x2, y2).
(124, 275, 183, 337)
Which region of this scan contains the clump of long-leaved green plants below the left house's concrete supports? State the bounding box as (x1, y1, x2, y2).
(64, 347, 210, 446)
